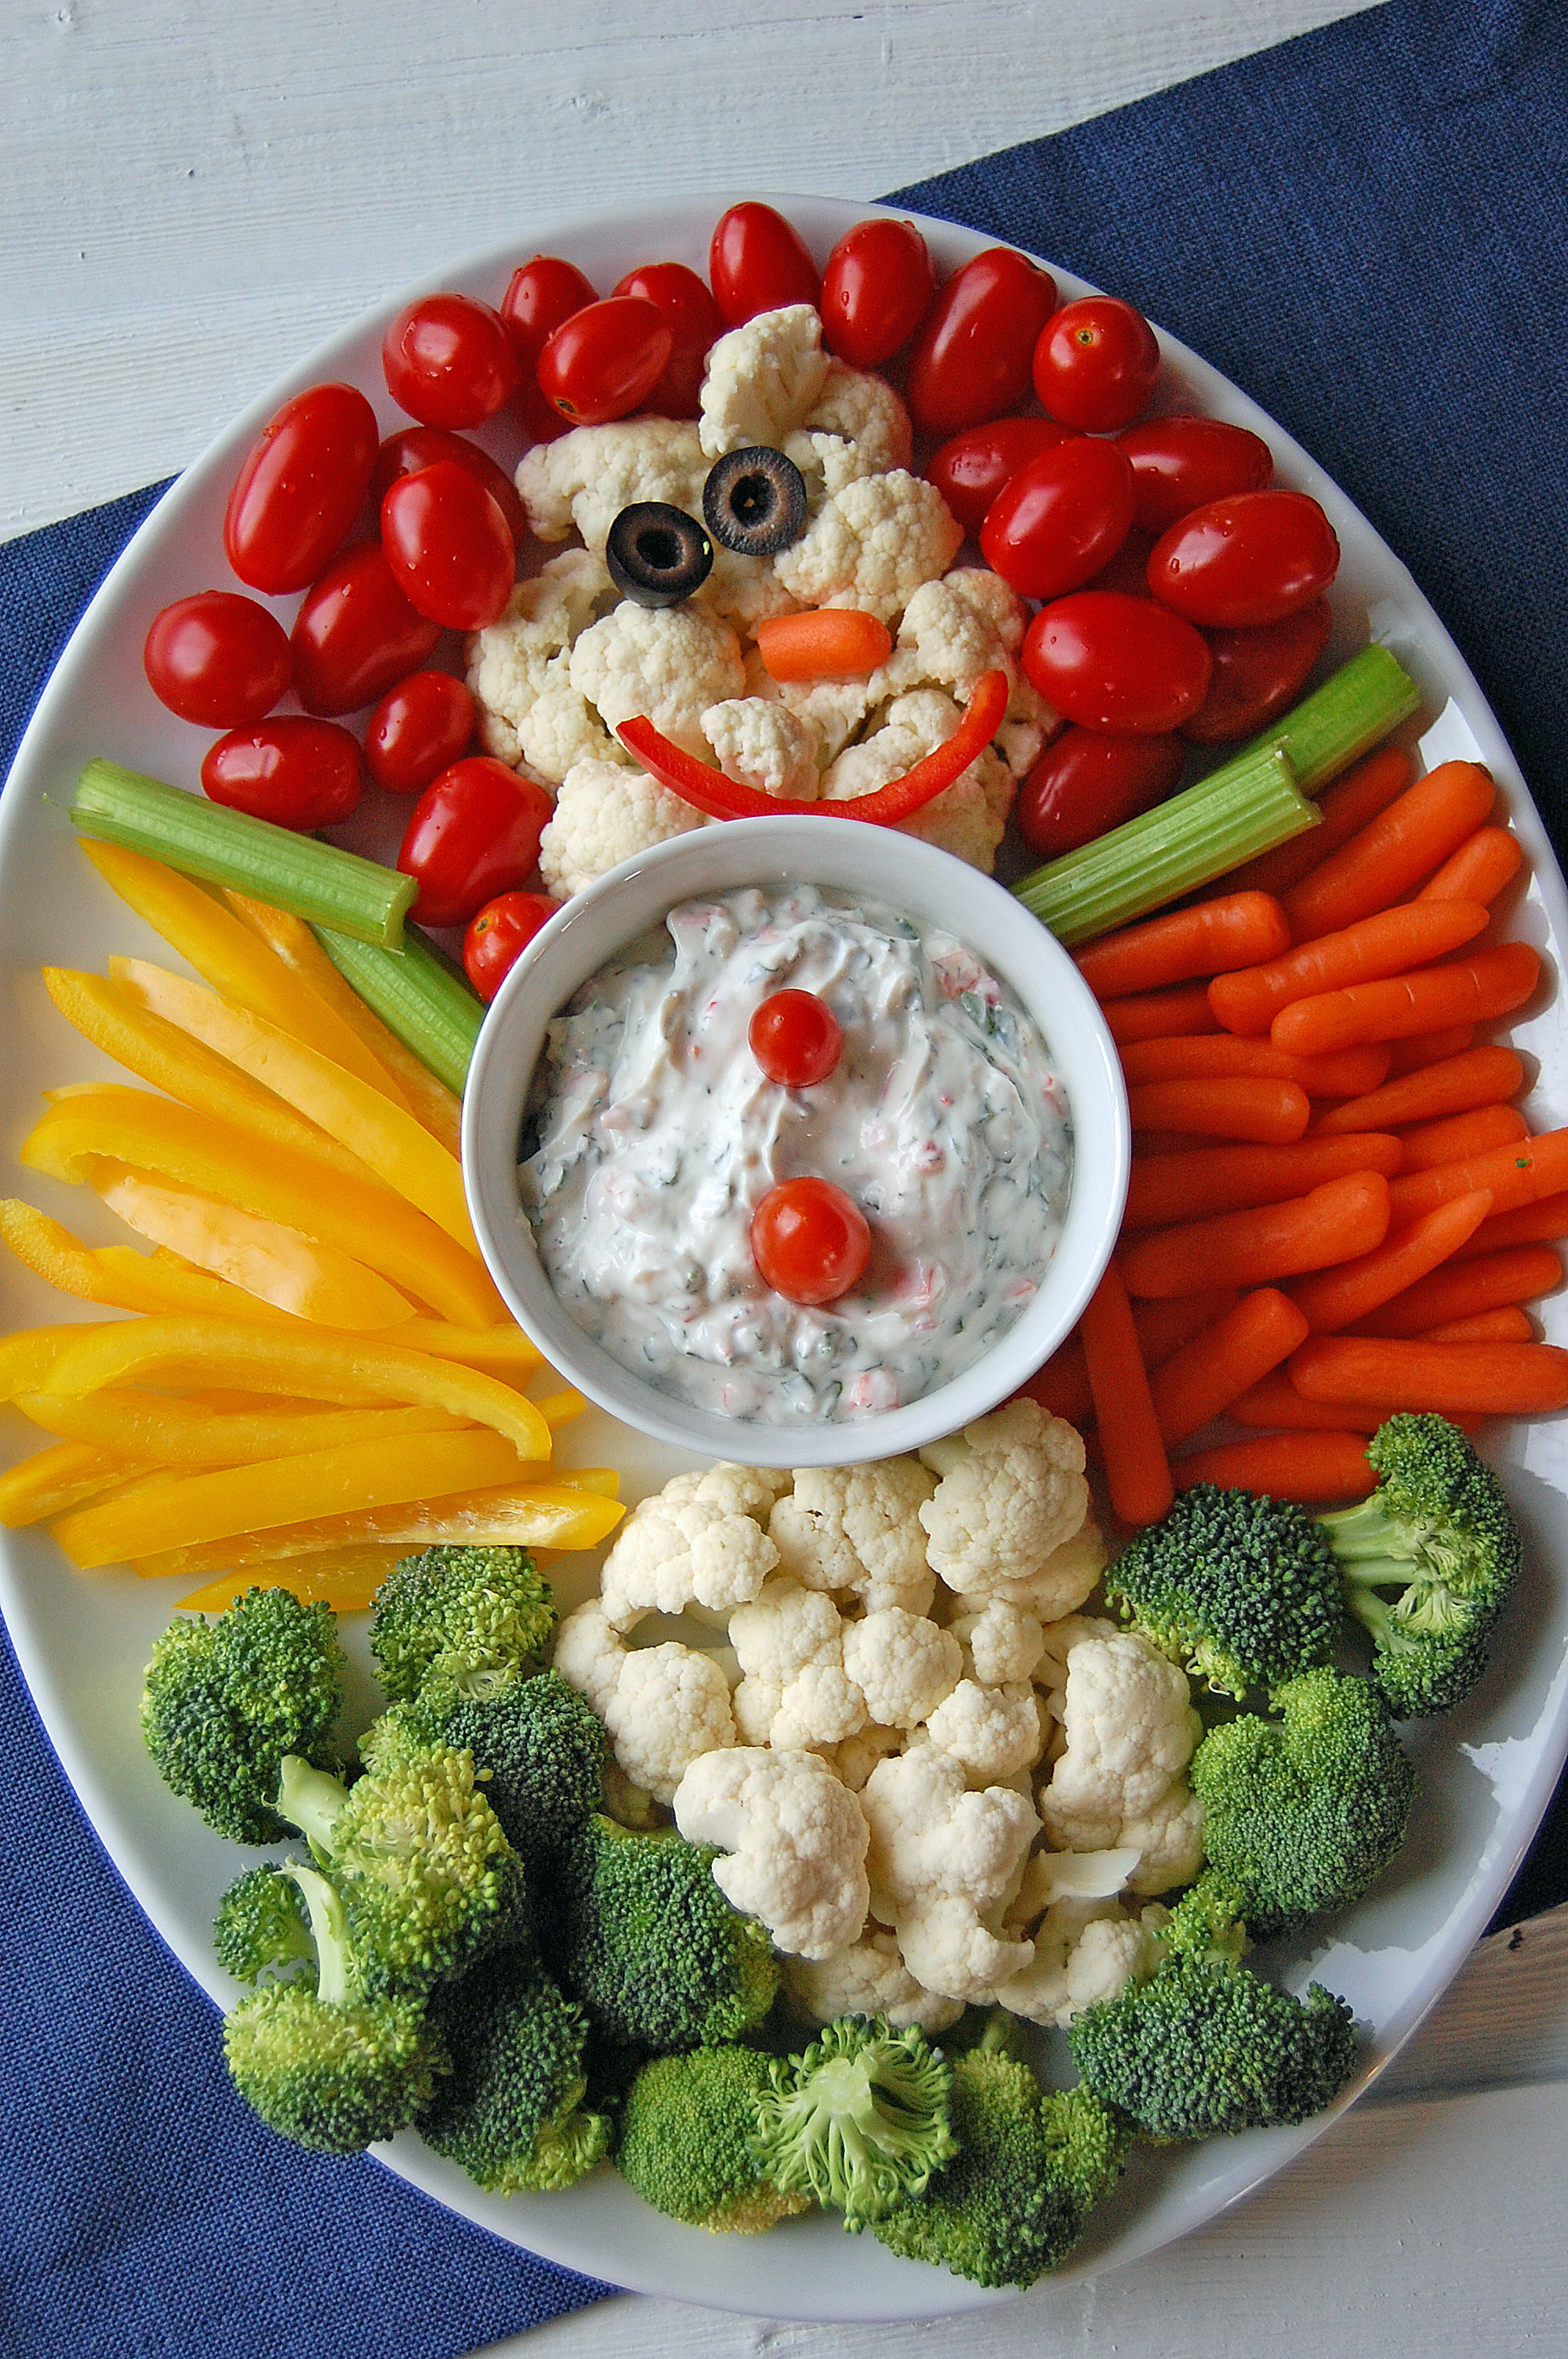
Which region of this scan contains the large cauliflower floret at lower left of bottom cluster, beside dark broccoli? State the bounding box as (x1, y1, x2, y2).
(674, 1746, 870, 1958)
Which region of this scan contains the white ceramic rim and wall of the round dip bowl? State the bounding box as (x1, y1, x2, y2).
(462, 814, 1132, 1467)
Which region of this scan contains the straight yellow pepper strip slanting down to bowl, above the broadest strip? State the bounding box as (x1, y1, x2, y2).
(108, 958, 479, 1257)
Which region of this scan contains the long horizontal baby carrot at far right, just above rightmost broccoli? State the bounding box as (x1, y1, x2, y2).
(1290, 1336, 1568, 1418)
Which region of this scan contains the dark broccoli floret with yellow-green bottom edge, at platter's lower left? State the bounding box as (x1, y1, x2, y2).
(417, 1944, 611, 2196)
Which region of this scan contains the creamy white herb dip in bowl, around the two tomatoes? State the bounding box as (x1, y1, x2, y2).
(519, 885, 1073, 1425)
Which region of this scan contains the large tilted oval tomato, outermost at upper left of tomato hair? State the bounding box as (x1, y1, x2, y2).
(224, 384, 379, 597)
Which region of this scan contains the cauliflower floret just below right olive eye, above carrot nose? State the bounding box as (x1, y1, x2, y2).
(773, 467, 964, 623)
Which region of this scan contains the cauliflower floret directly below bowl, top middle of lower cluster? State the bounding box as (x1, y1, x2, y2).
(768, 1458, 936, 1613)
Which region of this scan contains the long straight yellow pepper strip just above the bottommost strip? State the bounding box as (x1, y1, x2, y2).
(54, 1432, 532, 1571)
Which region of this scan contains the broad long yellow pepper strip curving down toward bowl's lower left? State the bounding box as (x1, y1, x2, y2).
(19, 1083, 505, 1325)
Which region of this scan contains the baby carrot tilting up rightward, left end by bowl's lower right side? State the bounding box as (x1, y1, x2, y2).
(1123, 1172, 1388, 1295)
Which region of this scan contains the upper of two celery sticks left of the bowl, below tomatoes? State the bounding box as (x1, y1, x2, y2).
(71, 762, 419, 951)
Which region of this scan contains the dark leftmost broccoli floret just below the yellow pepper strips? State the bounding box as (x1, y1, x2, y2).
(141, 1587, 347, 1842)
